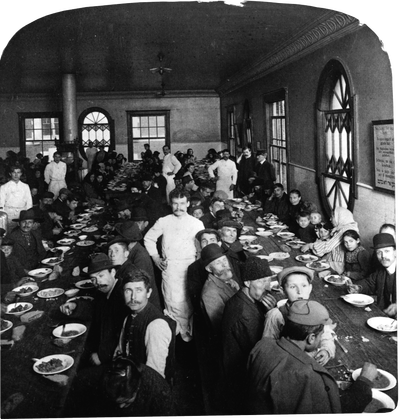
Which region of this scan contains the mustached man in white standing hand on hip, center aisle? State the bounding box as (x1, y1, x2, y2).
(144, 189, 204, 342)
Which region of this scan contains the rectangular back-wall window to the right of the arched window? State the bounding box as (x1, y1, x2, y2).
(127, 110, 171, 161)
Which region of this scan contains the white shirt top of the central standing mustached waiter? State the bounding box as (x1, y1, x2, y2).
(144, 213, 204, 260)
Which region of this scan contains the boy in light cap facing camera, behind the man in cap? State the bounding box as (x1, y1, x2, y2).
(263, 266, 336, 365)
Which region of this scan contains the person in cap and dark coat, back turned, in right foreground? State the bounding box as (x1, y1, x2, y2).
(248, 300, 377, 416)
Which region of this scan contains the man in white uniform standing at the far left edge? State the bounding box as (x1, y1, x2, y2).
(0, 166, 32, 232)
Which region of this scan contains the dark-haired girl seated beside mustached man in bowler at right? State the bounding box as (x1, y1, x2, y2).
(343, 230, 371, 280)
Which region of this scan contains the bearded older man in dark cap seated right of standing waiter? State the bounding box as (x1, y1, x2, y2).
(201, 243, 240, 338)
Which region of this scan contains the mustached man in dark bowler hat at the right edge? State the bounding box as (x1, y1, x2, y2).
(345, 233, 399, 317)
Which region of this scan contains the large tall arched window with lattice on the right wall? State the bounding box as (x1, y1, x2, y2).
(317, 60, 356, 214)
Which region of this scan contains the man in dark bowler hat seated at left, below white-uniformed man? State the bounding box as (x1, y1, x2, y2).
(7, 208, 46, 272)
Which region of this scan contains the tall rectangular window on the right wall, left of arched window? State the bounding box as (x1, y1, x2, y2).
(264, 89, 289, 190)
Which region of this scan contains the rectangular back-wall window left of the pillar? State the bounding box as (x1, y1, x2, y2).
(18, 112, 63, 161)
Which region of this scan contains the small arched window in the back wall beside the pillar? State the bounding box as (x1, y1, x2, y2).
(78, 108, 115, 151)
